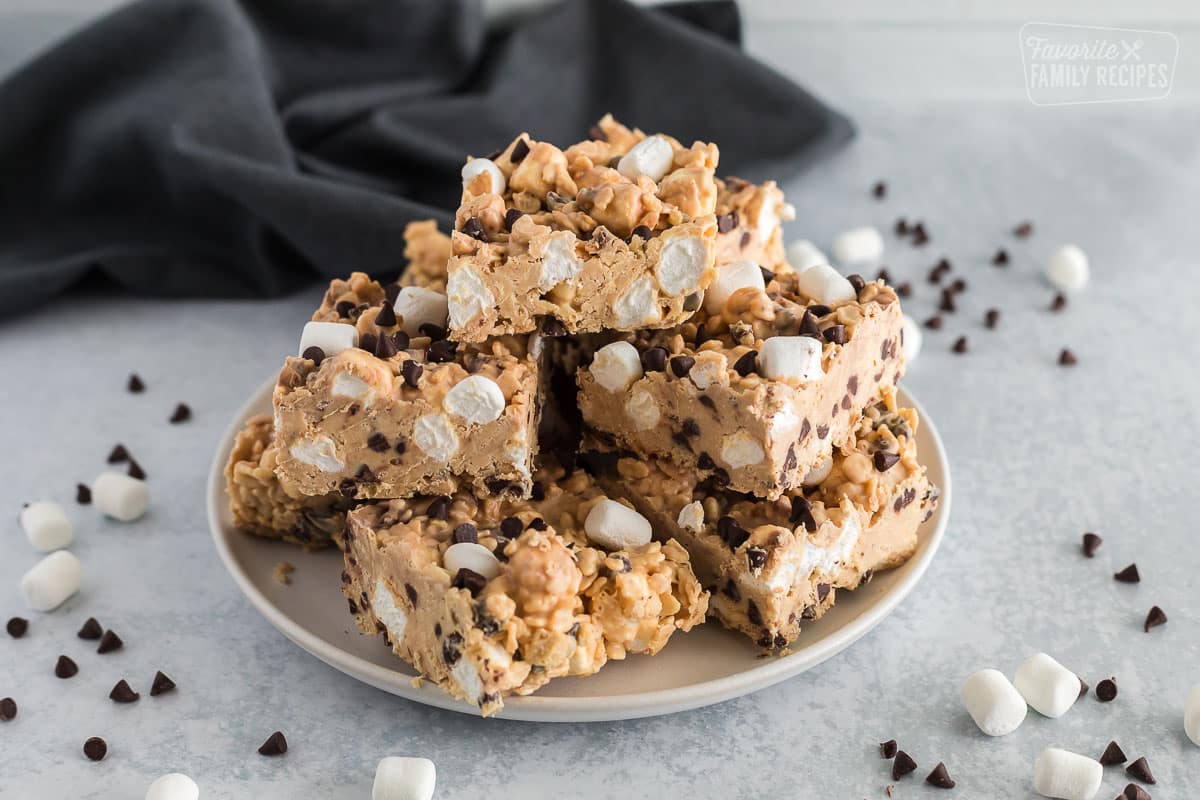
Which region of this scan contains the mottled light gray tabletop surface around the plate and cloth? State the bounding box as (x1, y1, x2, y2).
(0, 0, 1200, 800)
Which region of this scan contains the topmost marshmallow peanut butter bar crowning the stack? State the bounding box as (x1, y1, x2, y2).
(446, 116, 719, 342)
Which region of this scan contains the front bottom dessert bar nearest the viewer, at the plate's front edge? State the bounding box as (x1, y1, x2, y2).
(343, 460, 708, 715)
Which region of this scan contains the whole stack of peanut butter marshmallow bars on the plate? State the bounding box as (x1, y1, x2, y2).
(227, 118, 937, 714)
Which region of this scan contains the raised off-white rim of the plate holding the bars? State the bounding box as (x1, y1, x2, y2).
(205, 380, 953, 722)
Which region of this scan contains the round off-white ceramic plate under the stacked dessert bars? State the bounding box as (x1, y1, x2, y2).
(208, 384, 950, 722)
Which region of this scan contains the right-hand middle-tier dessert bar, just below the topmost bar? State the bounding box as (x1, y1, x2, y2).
(578, 265, 905, 499)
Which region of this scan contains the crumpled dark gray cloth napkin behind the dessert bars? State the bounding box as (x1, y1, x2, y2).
(0, 0, 853, 314)
